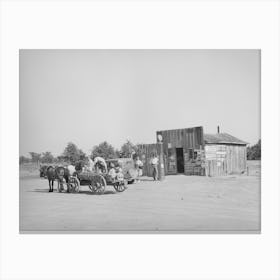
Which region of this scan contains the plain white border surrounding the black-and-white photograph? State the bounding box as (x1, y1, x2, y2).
(0, 0, 280, 279)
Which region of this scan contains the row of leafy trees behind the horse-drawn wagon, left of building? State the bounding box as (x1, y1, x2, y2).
(19, 140, 137, 164)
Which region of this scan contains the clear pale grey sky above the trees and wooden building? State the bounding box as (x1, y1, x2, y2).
(19, 50, 260, 156)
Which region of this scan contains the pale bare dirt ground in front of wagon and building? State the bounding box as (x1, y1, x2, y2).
(19, 164, 260, 232)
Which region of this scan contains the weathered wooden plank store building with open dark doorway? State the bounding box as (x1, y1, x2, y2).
(140, 126, 247, 176)
